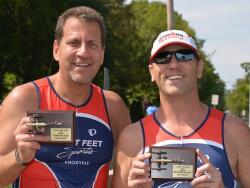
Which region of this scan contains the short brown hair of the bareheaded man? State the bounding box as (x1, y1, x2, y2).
(55, 6, 106, 47)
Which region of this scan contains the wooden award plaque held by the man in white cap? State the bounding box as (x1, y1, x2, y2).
(150, 146, 197, 181)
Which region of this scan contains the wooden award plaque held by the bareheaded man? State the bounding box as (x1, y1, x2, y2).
(27, 110, 75, 144)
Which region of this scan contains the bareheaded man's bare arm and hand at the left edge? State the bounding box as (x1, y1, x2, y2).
(0, 84, 48, 186)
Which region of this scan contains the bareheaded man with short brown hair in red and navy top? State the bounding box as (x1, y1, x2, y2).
(0, 6, 130, 188)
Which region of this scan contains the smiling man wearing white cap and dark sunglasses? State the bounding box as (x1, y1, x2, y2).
(112, 30, 250, 188)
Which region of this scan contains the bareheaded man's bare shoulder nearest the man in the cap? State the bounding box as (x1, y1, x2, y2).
(104, 91, 131, 140)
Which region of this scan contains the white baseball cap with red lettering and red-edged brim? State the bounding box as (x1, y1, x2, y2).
(150, 30, 198, 62)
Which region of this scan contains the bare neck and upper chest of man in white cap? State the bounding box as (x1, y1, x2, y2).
(156, 92, 208, 136)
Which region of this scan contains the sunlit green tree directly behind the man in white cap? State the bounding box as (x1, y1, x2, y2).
(125, 0, 225, 118)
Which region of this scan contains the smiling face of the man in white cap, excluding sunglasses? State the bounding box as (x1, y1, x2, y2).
(149, 45, 203, 95)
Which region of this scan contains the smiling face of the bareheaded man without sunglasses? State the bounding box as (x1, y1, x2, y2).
(53, 17, 104, 84)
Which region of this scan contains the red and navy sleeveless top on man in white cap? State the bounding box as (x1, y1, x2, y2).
(140, 108, 237, 188)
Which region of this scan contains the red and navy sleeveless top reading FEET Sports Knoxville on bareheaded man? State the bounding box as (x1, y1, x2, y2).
(13, 78, 114, 188)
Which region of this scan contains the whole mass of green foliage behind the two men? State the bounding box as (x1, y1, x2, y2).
(0, 0, 227, 121)
